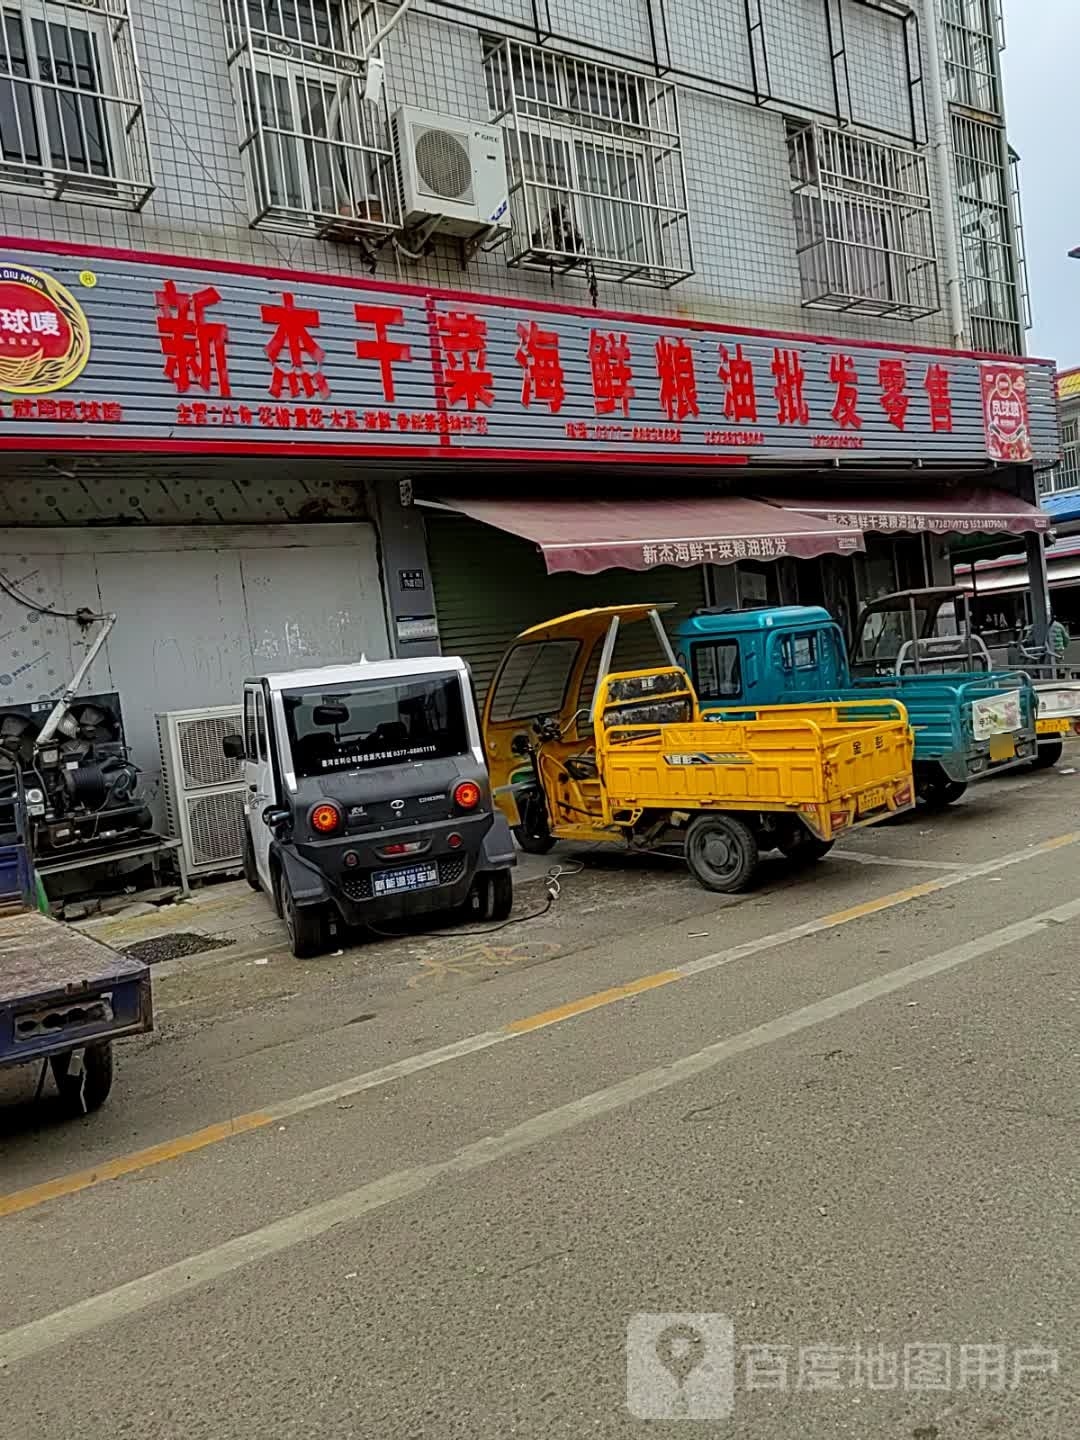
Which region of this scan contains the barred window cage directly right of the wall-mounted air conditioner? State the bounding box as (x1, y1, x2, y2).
(484, 39, 694, 289)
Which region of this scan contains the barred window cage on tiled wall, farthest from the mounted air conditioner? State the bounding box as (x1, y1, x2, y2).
(788, 121, 940, 320)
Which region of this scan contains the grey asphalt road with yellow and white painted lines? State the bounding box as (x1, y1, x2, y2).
(0, 759, 1080, 1440)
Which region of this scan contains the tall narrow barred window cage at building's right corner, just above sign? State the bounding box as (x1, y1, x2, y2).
(952, 115, 1025, 354)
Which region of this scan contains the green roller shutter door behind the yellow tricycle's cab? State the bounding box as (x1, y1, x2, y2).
(426, 513, 706, 701)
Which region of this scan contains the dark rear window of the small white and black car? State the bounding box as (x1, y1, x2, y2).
(282, 675, 468, 776)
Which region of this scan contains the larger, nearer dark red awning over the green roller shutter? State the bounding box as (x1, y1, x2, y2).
(442, 495, 865, 575)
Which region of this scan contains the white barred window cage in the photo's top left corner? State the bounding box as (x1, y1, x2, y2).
(0, 0, 154, 210)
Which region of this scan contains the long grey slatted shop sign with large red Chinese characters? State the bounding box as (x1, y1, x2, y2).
(0, 248, 1057, 464)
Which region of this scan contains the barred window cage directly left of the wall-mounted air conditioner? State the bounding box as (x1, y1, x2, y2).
(222, 0, 399, 239)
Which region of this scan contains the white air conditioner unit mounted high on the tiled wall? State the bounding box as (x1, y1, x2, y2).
(393, 105, 510, 238)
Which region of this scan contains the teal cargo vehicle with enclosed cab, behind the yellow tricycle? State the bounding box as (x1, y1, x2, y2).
(675, 605, 1037, 809)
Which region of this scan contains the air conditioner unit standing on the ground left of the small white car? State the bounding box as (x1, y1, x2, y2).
(157, 706, 248, 876)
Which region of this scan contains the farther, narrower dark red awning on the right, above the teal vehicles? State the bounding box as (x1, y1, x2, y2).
(770, 485, 1053, 534)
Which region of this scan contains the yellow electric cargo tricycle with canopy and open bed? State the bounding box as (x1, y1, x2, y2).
(484, 605, 914, 893)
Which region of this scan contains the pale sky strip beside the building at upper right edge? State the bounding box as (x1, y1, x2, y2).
(1002, 0, 1080, 370)
